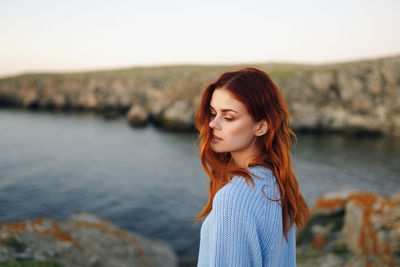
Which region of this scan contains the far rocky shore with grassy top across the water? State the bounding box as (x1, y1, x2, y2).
(0, 56, 400, 136)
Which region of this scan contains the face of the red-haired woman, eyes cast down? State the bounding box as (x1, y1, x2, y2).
(209, 88, 259, 157)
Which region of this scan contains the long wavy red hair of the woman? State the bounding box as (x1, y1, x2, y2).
(194, 68, 309, 243)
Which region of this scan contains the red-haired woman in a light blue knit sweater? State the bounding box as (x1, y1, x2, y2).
(195, 68, 309, 267)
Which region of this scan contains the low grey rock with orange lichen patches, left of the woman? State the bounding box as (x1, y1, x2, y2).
(0, 212, 178, 267)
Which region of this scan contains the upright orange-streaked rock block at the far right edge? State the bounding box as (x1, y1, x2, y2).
(342, 193, 400, 258)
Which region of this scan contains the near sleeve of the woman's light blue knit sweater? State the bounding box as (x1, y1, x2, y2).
(208, 179, 262, 267)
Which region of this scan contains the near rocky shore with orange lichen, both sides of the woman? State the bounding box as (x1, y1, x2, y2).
(0, 189, 400, 267)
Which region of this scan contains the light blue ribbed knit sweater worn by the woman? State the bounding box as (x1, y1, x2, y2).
(197, 166, 296, 267)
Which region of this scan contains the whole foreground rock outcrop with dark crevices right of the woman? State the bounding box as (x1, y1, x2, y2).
(297, 189, 400, 267)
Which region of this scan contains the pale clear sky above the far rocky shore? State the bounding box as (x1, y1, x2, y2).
(0, 0, 400, 77)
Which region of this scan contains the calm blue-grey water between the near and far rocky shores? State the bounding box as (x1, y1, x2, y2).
(0, 110, 400, 257)
